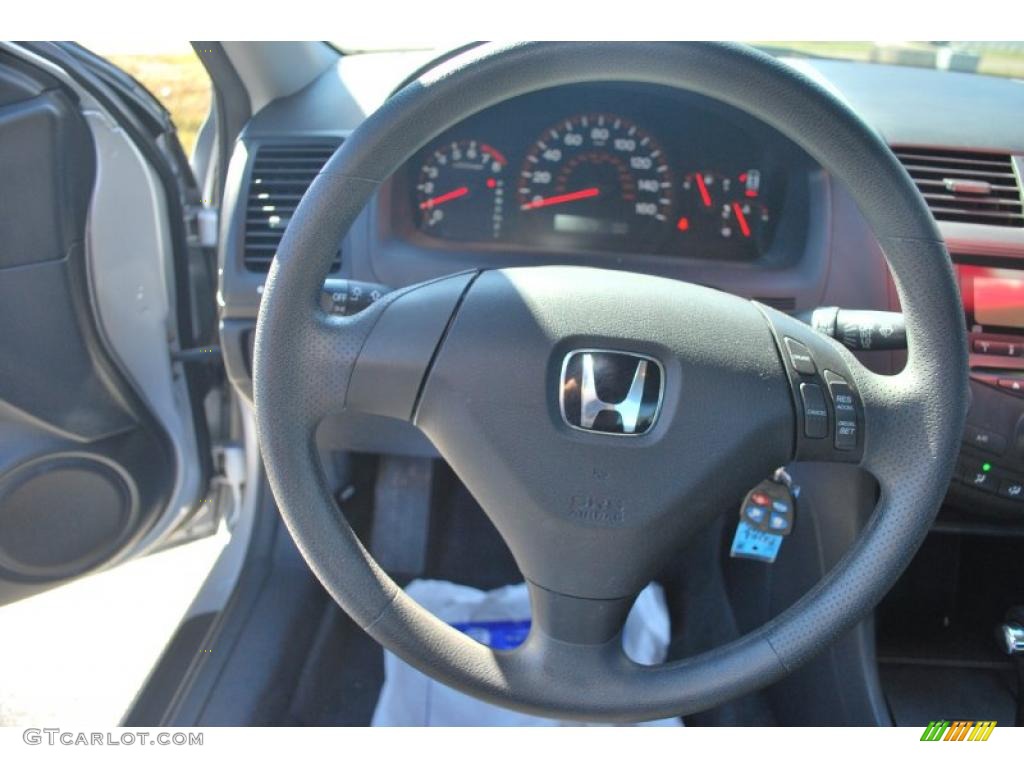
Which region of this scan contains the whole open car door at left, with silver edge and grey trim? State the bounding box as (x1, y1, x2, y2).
(0, 44, 220, 604)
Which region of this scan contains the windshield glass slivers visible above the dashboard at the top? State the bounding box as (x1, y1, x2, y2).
(333, 38, 1024, 79)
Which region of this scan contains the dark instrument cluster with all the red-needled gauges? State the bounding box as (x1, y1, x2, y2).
(392, 83, 810, 262)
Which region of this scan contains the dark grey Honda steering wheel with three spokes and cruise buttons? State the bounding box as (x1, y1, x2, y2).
(254, 43, 968, 722)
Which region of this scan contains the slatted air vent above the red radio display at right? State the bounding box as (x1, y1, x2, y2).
(893, 146, 1024, 226)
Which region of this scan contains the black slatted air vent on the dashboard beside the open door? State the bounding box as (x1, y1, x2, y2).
(245, 141, 341, 272)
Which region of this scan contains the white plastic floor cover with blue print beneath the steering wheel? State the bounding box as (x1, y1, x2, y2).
(372, 580, 682, 726)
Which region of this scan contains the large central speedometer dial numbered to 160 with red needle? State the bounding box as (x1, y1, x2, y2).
(516, 114, 673, 249)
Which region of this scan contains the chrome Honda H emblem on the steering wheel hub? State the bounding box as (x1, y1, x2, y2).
(558, 349, 665, 435)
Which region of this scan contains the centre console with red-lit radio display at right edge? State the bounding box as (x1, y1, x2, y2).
(876, 255, 1024, 726)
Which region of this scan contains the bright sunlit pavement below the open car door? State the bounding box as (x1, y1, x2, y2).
(0, 532, 228, 727)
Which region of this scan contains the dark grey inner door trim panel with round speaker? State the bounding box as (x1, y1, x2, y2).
(0, 52, 188, 603)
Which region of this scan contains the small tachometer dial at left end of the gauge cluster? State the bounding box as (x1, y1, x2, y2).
(416, 139, 508, 241)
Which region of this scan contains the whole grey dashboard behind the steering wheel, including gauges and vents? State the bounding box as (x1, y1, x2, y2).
(218, 52, 1024, 535)
